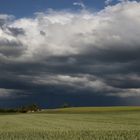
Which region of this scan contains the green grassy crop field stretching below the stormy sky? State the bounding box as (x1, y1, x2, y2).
(0, 107, 140, 140)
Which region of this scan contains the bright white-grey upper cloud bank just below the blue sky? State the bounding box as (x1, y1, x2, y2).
(4, 1, 140, 62)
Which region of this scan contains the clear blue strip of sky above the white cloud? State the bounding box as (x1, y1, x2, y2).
(0, 0, 112, 18)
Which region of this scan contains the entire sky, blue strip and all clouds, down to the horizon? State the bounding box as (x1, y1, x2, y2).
(0, 0, 140, 108)
